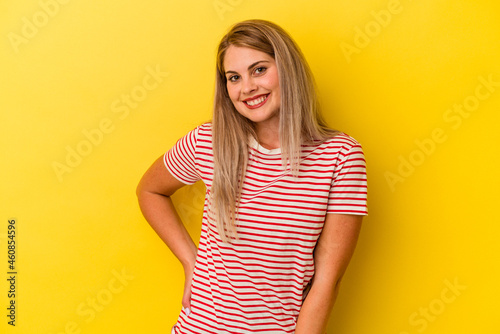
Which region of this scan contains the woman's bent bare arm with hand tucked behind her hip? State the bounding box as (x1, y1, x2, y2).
(136, 156, 197, 307)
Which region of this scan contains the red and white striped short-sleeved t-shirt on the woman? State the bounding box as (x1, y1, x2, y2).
(164, 123, 367, 334)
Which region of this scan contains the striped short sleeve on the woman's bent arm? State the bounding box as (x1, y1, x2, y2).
(163, 127, 200, 184)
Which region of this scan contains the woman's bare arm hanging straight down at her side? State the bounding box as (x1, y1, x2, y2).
(295, 214, 363, 334)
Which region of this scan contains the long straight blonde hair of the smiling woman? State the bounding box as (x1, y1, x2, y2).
(210, 20, 337, 242)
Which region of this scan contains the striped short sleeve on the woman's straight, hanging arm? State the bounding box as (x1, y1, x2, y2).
(327, 141, 368, 215)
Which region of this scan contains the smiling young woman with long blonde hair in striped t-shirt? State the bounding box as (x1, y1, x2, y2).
(137, 20, 367, 334)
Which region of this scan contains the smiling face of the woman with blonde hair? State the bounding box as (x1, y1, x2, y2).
(224, 45, 281, 130)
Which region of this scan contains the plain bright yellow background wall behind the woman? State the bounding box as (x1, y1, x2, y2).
(0, 0, 500, 334)
